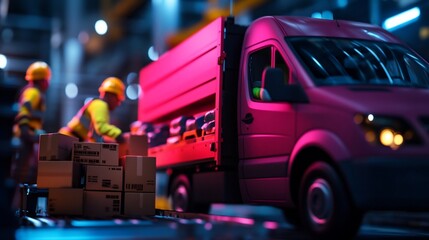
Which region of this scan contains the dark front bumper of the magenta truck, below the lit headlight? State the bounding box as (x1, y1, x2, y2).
(340, 156, 429, 211)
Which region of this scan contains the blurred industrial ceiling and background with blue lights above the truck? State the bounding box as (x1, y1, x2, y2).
(0, 0, 429, 132)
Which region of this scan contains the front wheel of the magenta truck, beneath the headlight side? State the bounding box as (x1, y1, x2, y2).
(299, 161, 362, 239)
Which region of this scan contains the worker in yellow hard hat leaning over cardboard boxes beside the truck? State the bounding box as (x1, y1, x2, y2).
(59, 77, 125, 143)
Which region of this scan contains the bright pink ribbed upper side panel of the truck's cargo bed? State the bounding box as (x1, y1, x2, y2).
(138, 19, 223, 122)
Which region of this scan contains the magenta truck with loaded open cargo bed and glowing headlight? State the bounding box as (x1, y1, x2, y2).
(138, 17, 429, 236)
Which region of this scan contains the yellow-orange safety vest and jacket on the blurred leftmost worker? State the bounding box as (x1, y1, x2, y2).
(13, 86, 46, 137)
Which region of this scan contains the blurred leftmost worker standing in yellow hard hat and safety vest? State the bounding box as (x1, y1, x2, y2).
(11, 61, 51, 183)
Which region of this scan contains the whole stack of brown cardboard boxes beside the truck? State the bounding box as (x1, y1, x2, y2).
(37, 133, 156, 218)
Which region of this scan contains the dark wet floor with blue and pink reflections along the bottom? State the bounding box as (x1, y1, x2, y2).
(10, 205, 429, 240)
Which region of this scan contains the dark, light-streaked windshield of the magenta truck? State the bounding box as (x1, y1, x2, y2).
(287, 37, 429, 88)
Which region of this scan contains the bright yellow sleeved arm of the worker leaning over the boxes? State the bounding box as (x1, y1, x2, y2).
(88, 100, 122, 139)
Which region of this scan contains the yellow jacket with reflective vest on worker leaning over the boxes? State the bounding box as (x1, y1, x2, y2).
(59, 99, 122, 142)
